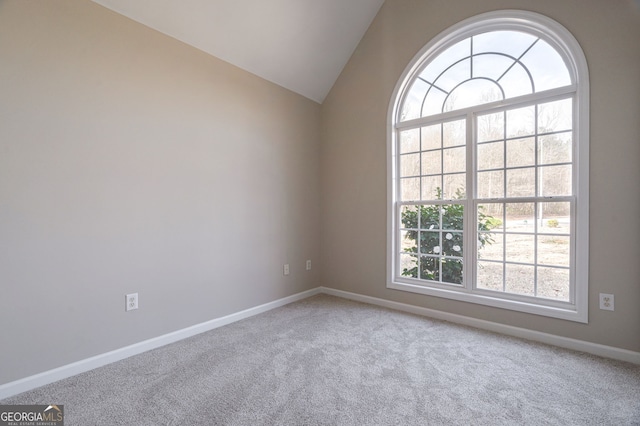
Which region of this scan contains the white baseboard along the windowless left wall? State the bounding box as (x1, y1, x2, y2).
(0, 288, 321, 400)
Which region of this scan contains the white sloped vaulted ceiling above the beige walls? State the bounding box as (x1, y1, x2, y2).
(93, 0, 384, 103)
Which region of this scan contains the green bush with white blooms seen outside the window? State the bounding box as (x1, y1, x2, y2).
(401, 188, 502, 284)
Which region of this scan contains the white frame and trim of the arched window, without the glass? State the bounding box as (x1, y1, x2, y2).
(387, 10, 589, 323)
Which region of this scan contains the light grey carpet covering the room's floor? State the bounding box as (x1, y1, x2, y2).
(0, 295, 640, 426)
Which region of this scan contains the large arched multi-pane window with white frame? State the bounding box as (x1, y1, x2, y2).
(388, 11, 589, 322)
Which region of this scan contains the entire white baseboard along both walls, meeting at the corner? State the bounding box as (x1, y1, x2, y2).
(0, 287, 640, 400)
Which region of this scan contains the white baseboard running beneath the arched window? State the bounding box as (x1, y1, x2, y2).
(320, 287, 640, 364)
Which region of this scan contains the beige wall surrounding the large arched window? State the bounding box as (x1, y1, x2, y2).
(321, 0, 640, 351)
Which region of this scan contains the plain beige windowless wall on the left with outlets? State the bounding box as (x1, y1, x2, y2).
(0, 0, 320, 384)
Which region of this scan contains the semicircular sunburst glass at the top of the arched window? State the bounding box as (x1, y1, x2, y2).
(398, 29, 574, 122)
